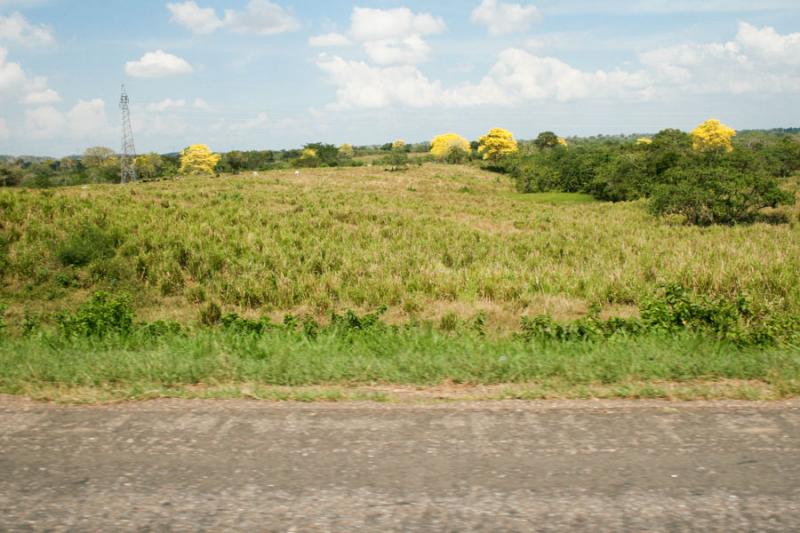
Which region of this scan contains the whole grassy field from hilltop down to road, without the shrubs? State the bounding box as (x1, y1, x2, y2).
(0, 164, 800, 397)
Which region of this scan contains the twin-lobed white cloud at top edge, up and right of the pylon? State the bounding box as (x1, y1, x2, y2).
(167, 0, 300, 35)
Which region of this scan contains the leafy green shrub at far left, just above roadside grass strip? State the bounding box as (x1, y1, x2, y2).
(58, 291, 134, 337)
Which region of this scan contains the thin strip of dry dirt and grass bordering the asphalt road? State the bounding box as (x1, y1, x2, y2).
(0, 380, 793, 405)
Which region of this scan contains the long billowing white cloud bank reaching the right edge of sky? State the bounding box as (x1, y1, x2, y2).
(317, 23, 800, 109)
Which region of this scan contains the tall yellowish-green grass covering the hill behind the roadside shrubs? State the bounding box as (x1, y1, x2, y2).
(0, 165, 800, 330)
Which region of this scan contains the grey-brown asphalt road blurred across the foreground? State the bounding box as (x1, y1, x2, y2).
(0, 398, 800, 532)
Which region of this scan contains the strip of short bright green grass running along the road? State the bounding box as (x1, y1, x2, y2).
(0, 327, 800, 399)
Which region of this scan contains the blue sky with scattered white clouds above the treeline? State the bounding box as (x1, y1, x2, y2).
(0, 0, 800, 156)
